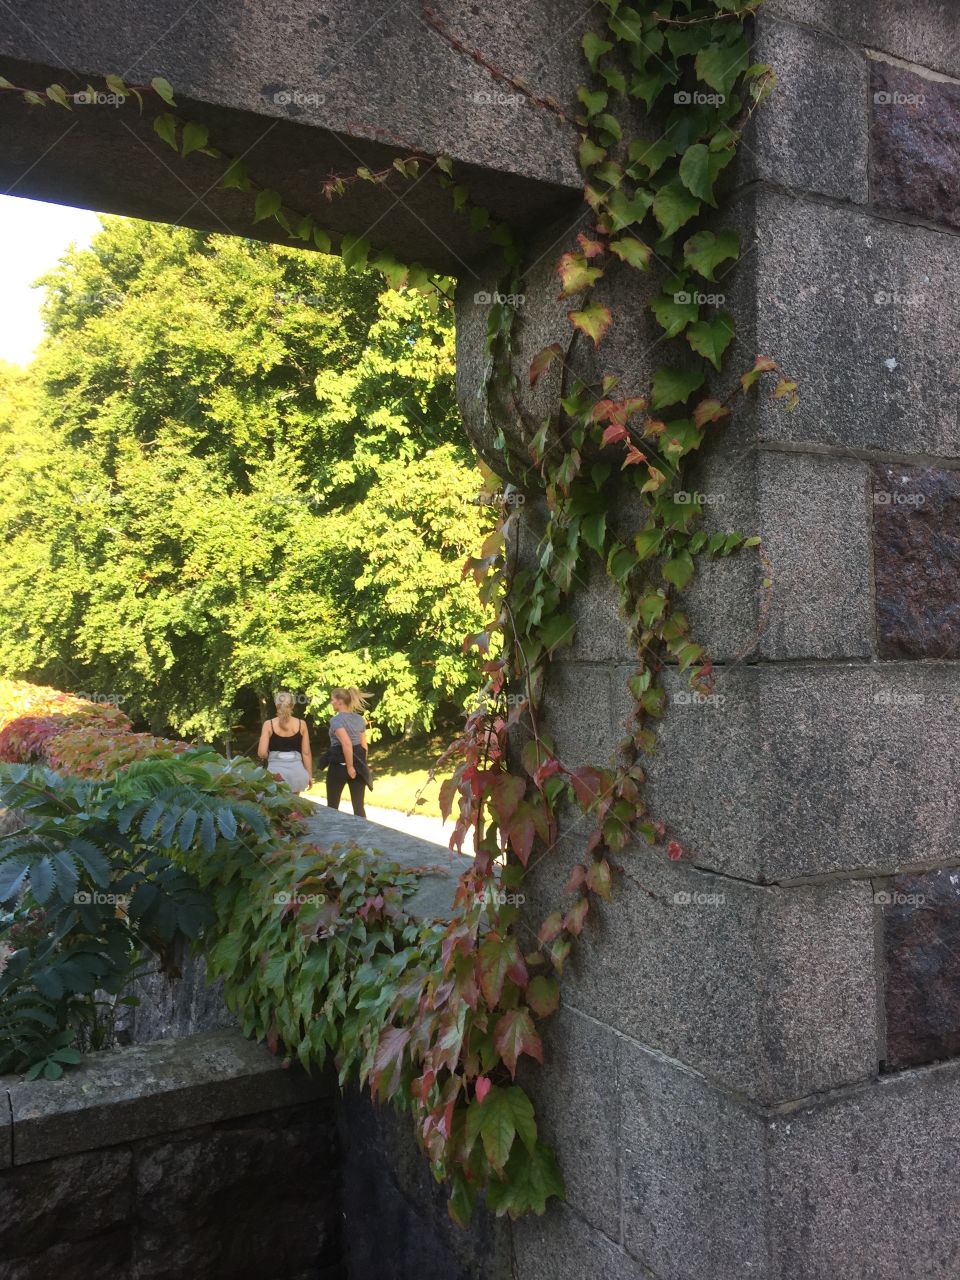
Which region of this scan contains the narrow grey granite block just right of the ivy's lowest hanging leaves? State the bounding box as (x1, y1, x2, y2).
(521, 1008, 621, 1240)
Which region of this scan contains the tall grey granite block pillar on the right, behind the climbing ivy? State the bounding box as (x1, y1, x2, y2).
(460, 0, 960, 1280)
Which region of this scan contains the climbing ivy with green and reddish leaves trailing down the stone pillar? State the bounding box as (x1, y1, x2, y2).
(7, 0, 797, 1222)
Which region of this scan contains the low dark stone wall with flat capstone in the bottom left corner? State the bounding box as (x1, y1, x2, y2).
(0, 1032, 344, 1280)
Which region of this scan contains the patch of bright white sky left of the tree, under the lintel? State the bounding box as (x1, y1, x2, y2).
(0, 196, 100, 365)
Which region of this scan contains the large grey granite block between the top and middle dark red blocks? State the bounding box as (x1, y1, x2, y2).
(727, 192, 960, 457)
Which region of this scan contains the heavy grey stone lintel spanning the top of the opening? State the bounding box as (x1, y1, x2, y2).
(0, 0, 589, 276)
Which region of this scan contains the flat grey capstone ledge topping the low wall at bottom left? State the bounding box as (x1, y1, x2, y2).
(0, 1030, 333, 1165)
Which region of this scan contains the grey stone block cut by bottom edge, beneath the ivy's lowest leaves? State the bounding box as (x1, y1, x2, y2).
(513, 1201, 650, 1280)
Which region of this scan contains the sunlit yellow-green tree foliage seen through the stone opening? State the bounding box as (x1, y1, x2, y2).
(0, 218, 484, 737)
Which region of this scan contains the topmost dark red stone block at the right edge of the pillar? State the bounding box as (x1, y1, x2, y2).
(870, 63, 960, 227)
